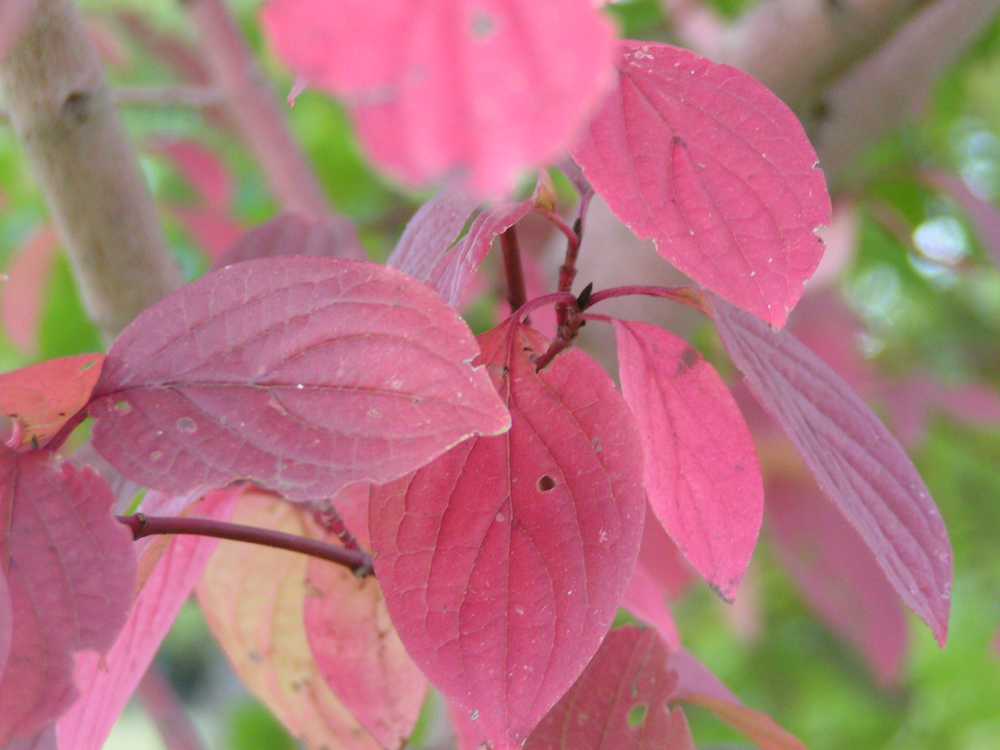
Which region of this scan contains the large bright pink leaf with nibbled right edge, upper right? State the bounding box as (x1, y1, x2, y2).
(573, 41, 832, 327)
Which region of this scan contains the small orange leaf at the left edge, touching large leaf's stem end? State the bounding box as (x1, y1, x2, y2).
(0, 354, 104, 446)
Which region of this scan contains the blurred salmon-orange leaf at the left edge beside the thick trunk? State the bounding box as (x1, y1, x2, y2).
(0, 227, 59, 354)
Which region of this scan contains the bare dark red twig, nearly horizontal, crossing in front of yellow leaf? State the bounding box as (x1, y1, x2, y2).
(118, 513, 375, 578)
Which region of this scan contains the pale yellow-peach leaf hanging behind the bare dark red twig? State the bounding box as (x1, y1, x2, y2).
(198, 493, 379, 750)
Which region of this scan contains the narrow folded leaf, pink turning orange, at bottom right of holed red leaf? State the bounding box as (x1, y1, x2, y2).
(670, 651, 806, 750)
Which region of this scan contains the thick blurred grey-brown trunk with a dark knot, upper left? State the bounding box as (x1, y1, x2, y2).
(0, 0, 181, 338)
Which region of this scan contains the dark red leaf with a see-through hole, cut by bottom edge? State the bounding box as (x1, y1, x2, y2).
(525, 628, 694, 750)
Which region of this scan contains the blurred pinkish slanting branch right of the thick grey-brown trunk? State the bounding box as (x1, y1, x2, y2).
(188, 0, 330, 218)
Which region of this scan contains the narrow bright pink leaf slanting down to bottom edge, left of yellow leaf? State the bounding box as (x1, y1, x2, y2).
(57, 490, 240, 750)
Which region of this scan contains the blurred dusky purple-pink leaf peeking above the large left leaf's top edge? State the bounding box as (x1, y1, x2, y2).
(215, 213, 368, 268)
